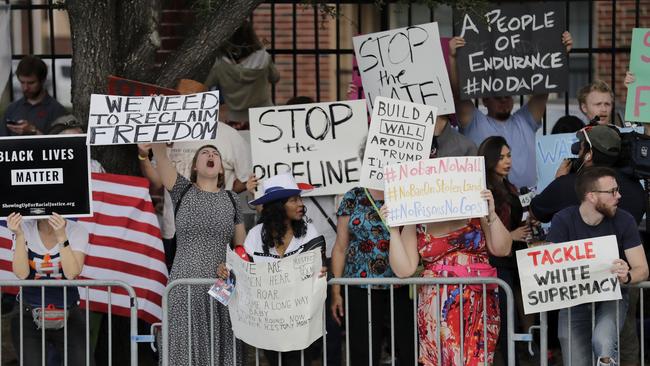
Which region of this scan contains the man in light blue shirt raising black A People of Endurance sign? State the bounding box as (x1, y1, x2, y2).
(449, 32, 573, 189)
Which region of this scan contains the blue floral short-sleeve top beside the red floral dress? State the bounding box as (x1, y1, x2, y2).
(336, 187, 395, 284)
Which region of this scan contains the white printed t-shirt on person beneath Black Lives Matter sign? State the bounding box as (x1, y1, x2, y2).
(17, 220, 88, 308)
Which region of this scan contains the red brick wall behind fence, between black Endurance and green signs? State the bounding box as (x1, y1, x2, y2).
(594, 0, 650, 107)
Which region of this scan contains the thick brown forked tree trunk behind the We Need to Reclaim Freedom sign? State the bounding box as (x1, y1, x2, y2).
(65, 0, 262, 175)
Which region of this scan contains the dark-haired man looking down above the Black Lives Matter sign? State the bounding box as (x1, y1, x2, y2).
(0, 56, 66, 136)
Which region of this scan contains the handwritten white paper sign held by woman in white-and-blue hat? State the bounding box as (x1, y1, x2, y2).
(227, 249, 327, 352)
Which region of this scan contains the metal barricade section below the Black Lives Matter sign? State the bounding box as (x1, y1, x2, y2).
(0, 280, 138, 366)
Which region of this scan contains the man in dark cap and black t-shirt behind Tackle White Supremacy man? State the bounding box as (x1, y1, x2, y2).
(530, 126, 646, 225)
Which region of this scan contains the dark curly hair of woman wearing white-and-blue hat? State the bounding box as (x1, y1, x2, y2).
(257, 198, 307, 253)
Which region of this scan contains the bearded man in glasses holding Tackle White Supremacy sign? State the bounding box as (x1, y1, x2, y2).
(547, 167, 648, 366)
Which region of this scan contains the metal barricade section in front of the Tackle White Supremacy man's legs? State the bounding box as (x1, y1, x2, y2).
(536, 281, 650, 366)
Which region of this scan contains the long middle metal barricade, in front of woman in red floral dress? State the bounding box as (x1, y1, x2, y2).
(161, 277, 520, 366)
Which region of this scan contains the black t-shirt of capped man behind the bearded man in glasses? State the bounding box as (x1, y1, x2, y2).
(530, 172, 646, 226)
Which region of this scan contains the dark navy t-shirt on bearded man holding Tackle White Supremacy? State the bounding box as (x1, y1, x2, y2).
(546, 206, 641, 259)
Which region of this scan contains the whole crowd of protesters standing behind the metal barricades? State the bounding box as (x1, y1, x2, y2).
(0, 17, 648, 365)
